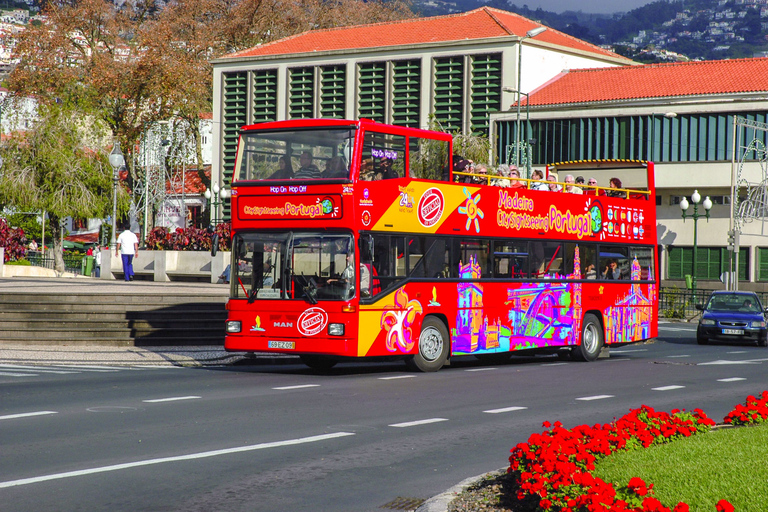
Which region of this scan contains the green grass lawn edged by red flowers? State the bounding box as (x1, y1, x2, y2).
(594, 424, 768, 512)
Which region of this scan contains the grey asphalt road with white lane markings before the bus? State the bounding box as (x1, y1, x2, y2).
(0, 324, 768, 512)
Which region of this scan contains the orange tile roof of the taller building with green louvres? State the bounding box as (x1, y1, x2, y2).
(223, 7, 631, 63)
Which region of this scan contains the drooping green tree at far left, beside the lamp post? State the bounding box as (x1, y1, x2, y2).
(0, 103, 128, 272)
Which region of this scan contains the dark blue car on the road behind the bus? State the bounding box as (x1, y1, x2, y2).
(696, 291, 768, 347)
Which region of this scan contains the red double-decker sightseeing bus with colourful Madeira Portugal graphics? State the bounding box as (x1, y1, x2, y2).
(219, 119, 658, 371)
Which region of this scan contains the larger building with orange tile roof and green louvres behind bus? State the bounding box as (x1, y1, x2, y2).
(213, 7, 634, 192)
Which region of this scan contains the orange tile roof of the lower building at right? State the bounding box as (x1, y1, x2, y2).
(522, 58, 768, 106)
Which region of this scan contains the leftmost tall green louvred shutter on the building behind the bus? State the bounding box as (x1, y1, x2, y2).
(221, 72, 248, 219)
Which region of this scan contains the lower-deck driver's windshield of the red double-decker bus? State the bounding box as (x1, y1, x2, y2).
(232, 231, 357, 304)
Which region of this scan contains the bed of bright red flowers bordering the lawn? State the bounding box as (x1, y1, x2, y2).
(508, 391, 768, 512)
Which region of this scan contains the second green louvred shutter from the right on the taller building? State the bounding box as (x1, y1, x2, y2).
(434, 57, 464, 131)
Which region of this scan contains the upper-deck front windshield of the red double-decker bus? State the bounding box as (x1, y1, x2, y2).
(234, 127, 355, 181)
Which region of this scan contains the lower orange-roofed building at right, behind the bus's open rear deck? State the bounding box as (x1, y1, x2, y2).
(491, 58, 768, 290)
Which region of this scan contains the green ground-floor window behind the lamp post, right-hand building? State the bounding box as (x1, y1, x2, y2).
(667, 246, 748, 281)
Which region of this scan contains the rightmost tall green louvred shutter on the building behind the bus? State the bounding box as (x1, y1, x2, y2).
(470, 53, 500, 135)
